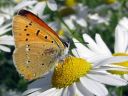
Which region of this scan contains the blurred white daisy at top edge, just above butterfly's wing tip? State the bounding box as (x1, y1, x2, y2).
(14, 0, 57, 17)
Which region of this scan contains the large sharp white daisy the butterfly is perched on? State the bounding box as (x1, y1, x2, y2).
(23, 43, 128, 96)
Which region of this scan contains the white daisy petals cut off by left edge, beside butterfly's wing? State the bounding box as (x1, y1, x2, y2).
(0, 23, 14, 52)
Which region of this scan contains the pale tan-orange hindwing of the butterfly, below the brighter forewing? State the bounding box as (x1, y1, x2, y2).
(13, 42, 59, 80)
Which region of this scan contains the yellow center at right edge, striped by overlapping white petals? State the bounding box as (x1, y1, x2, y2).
(108, 53, 128, 75)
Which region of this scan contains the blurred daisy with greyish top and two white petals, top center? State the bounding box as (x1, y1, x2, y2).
(63, 4, 88, 30)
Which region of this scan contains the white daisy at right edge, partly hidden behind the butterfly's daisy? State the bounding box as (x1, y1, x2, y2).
(72, 17, 128, 80)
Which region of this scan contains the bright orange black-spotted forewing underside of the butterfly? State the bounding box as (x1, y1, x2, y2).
(13, 16, 60, 47)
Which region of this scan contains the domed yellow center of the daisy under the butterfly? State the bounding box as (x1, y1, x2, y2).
(52, 56, 92, 88)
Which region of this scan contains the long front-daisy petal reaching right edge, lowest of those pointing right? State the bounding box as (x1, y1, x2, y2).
(87, 74, 128, 86)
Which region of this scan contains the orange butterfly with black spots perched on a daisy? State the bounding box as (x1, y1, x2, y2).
(12, 9, 68, 80)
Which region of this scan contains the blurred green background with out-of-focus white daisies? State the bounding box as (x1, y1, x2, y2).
(0, 0, 128, 96)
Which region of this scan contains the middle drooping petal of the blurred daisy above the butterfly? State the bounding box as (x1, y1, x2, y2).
(33, 2, 46, 17)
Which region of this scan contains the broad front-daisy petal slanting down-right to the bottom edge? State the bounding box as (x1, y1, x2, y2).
(80, 77, 108, 96)
